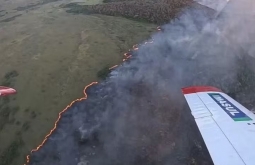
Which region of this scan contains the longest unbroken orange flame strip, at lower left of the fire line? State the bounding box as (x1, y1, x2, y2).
(24, 82, 98, 165)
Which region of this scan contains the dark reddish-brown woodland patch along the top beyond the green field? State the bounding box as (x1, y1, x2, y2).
(62, 0, 216, 24)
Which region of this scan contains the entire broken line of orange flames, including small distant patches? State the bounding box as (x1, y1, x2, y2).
(24, 26, 161, 165)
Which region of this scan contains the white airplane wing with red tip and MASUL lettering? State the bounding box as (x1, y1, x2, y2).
(182, 86, 255, 165)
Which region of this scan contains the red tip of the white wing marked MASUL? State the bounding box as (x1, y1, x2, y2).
(182, 86, 222, 94)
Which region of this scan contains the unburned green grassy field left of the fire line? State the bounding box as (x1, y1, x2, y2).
(0, 0, 157, 165)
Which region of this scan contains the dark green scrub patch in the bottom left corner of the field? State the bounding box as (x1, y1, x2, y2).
(0, 137, 24, 165)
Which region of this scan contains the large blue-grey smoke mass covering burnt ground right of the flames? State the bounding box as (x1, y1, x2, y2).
(29, 0, 255, 165)
